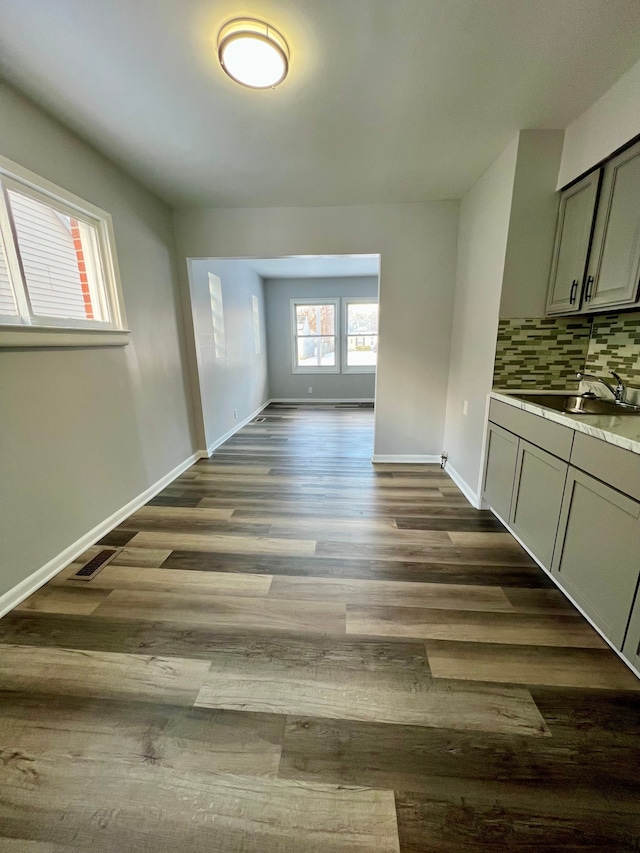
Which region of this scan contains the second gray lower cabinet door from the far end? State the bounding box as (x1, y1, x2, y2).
(508, 439, 569, 569)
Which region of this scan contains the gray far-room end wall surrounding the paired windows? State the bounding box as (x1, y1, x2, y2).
(265, 276, 378, 400)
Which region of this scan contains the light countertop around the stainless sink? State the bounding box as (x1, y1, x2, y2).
(490, 389, 640, 454)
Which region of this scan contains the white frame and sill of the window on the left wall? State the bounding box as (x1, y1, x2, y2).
(0, 156, 130, 347)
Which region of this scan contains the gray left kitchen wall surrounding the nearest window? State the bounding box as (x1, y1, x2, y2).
(0, 81, 195, 594)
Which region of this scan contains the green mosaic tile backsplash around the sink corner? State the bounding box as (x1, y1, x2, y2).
(493, 312, 640, 390)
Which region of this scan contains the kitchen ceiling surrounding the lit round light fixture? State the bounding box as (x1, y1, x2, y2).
(0, 0, 640, 207)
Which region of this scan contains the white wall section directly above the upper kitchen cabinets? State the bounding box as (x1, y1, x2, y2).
(557, 57, 640, 188)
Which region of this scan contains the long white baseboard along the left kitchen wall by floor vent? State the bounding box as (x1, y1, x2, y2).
(0, 452, 202, 617)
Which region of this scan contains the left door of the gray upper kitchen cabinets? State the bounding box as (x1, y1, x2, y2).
(547, 169, 601, 314)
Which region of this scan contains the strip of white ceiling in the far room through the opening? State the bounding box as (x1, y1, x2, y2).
(242, 255, 380, 279)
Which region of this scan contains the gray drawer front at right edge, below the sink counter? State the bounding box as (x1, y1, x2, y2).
(571, 432, 640, 501)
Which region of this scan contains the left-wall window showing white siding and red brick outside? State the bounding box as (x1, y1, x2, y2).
(0, 156, 125, 345)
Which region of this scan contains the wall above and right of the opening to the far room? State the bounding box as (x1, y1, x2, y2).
(176, 201, 458, 455)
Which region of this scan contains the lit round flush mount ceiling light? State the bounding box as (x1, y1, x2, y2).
(218, 18, 289, 89)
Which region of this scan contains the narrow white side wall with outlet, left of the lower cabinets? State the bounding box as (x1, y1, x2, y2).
(444, 136, 519, 498)
